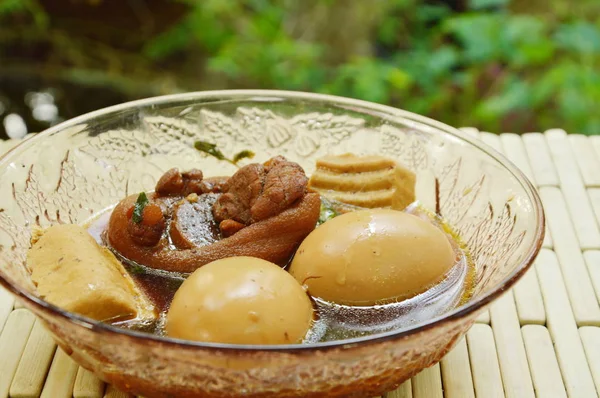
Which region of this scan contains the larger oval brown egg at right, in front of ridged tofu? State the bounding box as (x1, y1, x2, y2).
(290, 209, 456, 305)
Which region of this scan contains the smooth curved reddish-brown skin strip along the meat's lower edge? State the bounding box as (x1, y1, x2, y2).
(108, 192, 321, 272)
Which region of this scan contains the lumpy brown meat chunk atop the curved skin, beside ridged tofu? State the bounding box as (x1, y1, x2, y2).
(213, 156, 308, 225)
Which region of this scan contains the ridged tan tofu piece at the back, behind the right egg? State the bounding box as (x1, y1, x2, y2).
(309, 153, 416, 210)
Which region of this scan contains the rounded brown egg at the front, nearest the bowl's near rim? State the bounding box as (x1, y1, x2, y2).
(166, 257, 313, 344)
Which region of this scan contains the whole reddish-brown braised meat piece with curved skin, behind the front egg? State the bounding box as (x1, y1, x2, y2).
(107, 156, 321, 272)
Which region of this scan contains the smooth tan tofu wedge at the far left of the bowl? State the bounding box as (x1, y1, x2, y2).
(27, 224, 156, 322)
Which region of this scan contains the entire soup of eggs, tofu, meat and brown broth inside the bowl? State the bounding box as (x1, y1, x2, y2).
(27, 152, 474, 344)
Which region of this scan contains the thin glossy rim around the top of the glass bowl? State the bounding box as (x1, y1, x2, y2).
(0, 90, 545, 354)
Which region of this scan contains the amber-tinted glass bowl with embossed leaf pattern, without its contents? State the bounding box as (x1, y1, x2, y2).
(0, 90, 544, 397)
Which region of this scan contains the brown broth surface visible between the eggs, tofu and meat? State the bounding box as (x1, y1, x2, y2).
(88, 203, 475, 343)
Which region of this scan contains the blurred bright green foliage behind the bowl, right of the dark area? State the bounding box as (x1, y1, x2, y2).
(0, 0, 600, 134)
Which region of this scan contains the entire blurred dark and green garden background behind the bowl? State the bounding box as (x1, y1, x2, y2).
(0, 0, 600, 138)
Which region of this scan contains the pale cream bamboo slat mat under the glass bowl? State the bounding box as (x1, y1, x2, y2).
(0, 128, 600, 398)
